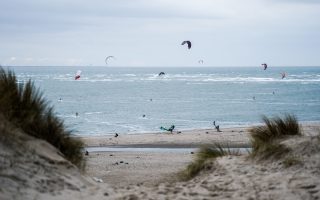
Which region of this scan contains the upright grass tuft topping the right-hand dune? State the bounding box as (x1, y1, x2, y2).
(249, 114, 301, 159)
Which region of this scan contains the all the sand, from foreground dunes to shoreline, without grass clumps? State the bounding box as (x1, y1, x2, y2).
(0, 123, 320, 200)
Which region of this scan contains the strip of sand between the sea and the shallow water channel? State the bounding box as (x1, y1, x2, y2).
(81, 127, 249, 148)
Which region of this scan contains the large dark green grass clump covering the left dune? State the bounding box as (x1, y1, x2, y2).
(0, 67, 85, 169)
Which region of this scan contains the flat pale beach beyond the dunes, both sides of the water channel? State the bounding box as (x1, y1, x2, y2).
(81, 123, 320, 187)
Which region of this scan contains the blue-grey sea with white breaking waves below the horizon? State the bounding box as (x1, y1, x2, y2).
(9, 66, 320, 135)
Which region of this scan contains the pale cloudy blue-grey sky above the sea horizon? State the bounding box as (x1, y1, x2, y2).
(0, 0, 320, 67)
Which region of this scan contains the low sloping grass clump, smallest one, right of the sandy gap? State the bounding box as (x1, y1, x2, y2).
(178, 144, 239, 181)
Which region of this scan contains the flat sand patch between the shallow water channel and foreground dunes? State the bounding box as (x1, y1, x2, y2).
(86, 152, 194, 187)
